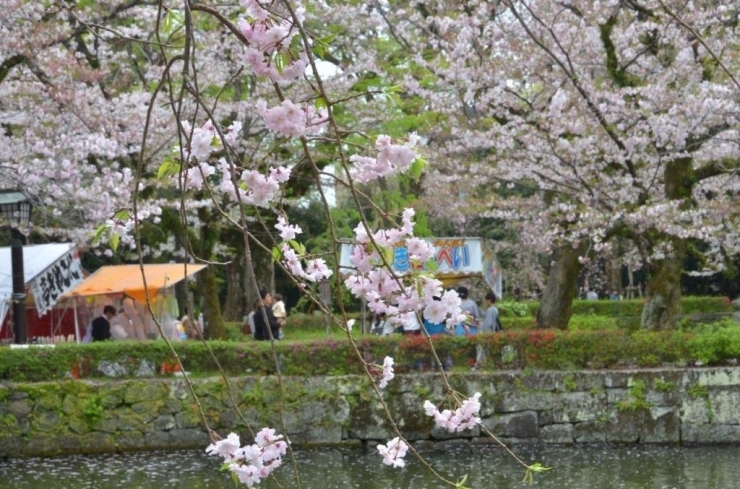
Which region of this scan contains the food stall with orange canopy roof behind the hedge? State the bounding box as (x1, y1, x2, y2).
(64, 263, 206, 341)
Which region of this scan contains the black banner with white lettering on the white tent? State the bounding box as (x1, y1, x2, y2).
(30, 250, 84, 316)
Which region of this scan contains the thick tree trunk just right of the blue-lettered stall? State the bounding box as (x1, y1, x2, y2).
(537, 244, 581, 329)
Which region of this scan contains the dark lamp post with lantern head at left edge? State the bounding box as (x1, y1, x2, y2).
(0, 190, 31, 343)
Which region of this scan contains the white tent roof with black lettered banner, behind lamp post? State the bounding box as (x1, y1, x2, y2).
(0, 243, 84, 328)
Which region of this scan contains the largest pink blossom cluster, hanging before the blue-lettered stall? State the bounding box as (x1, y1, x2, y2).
(344, 209, 464, 326)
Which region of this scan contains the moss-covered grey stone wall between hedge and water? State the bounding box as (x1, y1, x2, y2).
(0, 367, 740, 457)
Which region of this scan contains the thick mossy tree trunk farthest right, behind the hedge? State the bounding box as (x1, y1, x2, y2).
(640, 238, 686, 330)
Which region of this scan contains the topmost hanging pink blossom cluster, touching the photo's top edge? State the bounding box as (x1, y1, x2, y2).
(238, 0, 308, 82)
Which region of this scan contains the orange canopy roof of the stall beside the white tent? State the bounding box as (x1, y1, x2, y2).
(64, 263, 206, 303)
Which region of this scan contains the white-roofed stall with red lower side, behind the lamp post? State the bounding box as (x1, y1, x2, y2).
(0, 243, 84, 343)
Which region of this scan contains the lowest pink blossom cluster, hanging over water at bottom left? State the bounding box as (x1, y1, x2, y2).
(206, 428, 288, 487)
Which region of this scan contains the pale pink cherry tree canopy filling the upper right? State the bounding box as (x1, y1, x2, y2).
(326, 0, 740, 328)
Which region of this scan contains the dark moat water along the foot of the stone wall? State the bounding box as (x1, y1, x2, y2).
(0, 445, 740, 489)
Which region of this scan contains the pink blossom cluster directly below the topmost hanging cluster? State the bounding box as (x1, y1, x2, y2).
(256, 99, 328, 137)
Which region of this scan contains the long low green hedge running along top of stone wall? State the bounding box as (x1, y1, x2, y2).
(0, 320, 740, 381)
